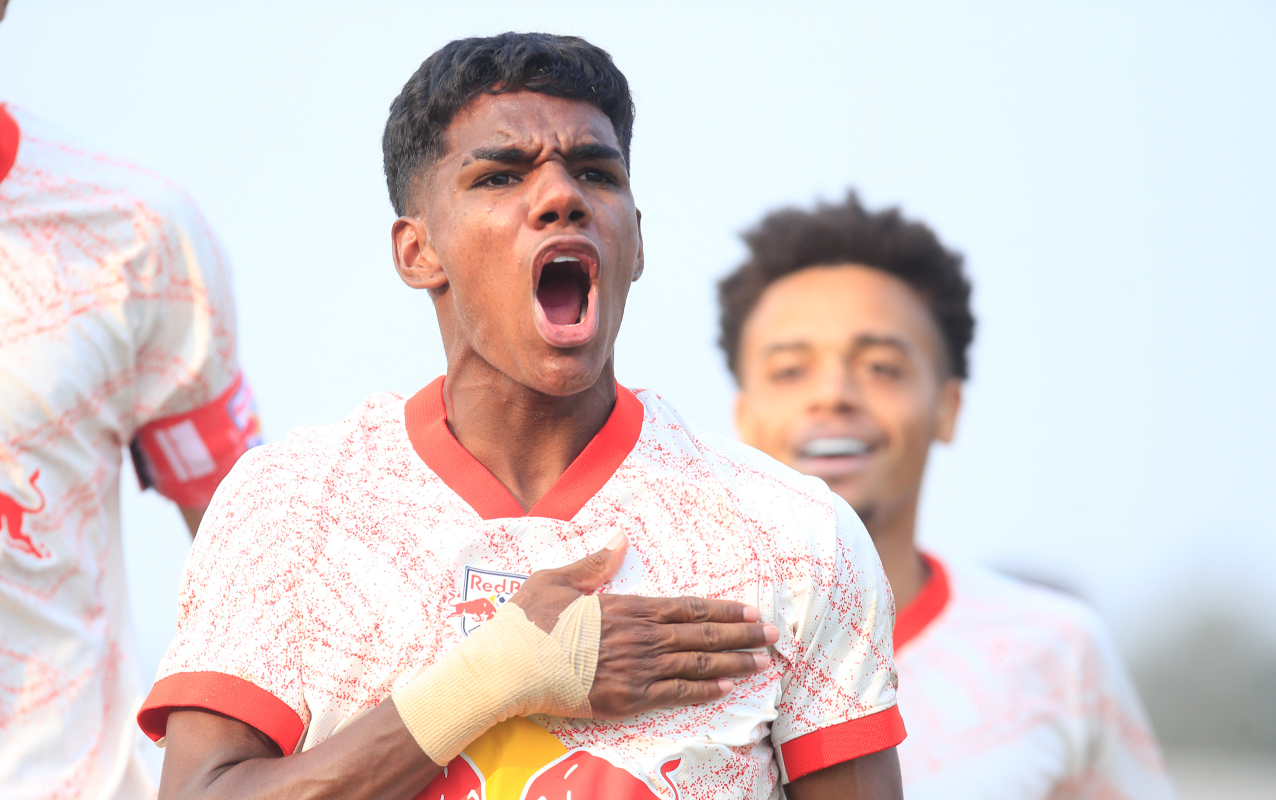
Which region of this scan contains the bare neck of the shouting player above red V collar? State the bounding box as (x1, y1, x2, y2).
(443, 360, 616, 510)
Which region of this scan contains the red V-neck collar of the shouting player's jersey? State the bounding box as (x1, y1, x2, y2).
(403, 376, 643, 522)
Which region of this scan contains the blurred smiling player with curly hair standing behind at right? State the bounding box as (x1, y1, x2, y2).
(720, 193, 1173, 800)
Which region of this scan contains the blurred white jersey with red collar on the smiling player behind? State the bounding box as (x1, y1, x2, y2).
(894, 556, 1174, 800)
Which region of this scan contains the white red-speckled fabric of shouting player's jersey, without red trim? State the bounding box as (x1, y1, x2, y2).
(144, 392, 902, 797)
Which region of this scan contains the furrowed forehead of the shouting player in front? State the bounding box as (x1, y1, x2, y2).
(443, 92, 620, 165)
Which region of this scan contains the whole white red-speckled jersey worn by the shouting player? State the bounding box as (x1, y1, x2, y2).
(139, 379, 903, 800)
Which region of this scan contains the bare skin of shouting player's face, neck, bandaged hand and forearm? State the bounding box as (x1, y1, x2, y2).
(149, 92, 796, 800)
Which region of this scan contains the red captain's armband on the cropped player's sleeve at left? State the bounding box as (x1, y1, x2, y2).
(130, 373, 262, 508)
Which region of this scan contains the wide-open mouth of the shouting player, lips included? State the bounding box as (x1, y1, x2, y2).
(533, 241, 598, 347)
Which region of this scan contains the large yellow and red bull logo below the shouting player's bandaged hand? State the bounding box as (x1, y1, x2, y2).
(417, 717, 683, 800)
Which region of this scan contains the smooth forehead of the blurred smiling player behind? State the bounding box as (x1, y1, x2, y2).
(741, 264, 943, 364)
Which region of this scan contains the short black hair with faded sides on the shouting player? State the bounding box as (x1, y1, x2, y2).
(382, 33, 634, 216)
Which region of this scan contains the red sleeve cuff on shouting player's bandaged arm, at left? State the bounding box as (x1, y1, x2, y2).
(138, 672, 305, 755)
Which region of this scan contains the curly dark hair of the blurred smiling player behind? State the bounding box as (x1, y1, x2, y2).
(718, 191, 975, 381)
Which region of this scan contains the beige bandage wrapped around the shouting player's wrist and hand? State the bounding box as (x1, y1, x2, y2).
(390, 596, 602, 766)
